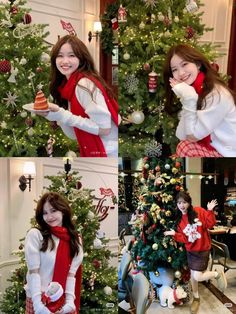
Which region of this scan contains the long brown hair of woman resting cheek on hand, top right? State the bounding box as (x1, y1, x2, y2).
(163, 44, 236, 114)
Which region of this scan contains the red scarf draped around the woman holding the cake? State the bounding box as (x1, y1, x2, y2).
(59, 71, 118, 157)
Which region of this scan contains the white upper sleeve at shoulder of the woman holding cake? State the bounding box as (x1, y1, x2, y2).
(75, 78, 111, 129)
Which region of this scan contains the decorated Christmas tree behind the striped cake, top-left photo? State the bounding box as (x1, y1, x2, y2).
(0, 0, 75, 157)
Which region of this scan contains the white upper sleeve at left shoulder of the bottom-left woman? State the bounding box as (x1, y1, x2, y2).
(25, 228, 43, 270)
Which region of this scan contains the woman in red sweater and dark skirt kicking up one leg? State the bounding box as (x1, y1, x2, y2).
(164, 192, 227, 314)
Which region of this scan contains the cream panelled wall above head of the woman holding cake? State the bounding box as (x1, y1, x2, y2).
(27, 0, 100, 69)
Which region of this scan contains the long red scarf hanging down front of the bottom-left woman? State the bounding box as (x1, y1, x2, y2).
(51, 227, 82, 313)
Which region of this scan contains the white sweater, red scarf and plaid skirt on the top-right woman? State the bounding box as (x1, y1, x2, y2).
(173, 72, 236, 157)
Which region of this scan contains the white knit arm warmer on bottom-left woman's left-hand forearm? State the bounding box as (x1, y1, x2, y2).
(27, 273, 51, 314)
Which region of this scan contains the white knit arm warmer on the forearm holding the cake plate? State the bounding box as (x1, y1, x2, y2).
(46, 108, 99, 135)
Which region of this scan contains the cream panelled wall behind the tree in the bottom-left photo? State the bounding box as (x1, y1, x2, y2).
(0, 158, 118, 296)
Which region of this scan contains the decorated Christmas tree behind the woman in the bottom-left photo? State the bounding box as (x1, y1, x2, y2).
(0, 168, 117, 314)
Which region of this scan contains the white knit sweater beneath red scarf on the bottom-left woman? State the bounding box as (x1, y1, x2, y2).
(25, 228, 83, 298)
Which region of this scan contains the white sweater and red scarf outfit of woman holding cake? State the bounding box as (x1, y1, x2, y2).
(46, 71, 118, 157)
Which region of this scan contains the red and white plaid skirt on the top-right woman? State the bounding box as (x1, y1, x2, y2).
(176, 140, 223, 157)
